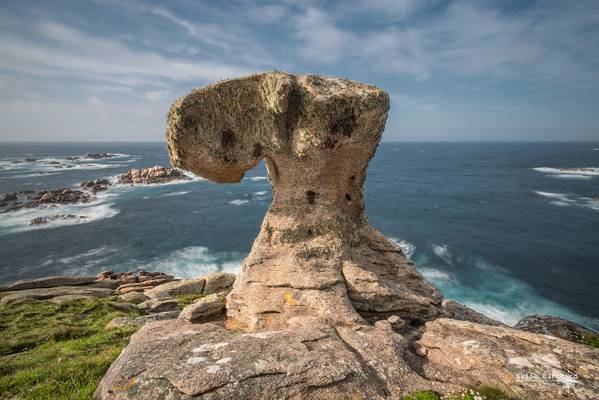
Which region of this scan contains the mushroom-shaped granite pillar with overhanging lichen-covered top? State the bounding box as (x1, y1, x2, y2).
(167, 72, 441, 331)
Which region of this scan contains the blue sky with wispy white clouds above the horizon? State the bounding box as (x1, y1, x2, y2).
(0, 0, 599, 141)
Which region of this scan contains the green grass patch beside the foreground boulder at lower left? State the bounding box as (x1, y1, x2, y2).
(0, 299, 140, 400)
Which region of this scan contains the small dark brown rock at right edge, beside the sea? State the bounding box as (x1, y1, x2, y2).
(514, 315, 599, 343)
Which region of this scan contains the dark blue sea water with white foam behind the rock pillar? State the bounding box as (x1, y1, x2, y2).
(0, 142, 599, 329)
